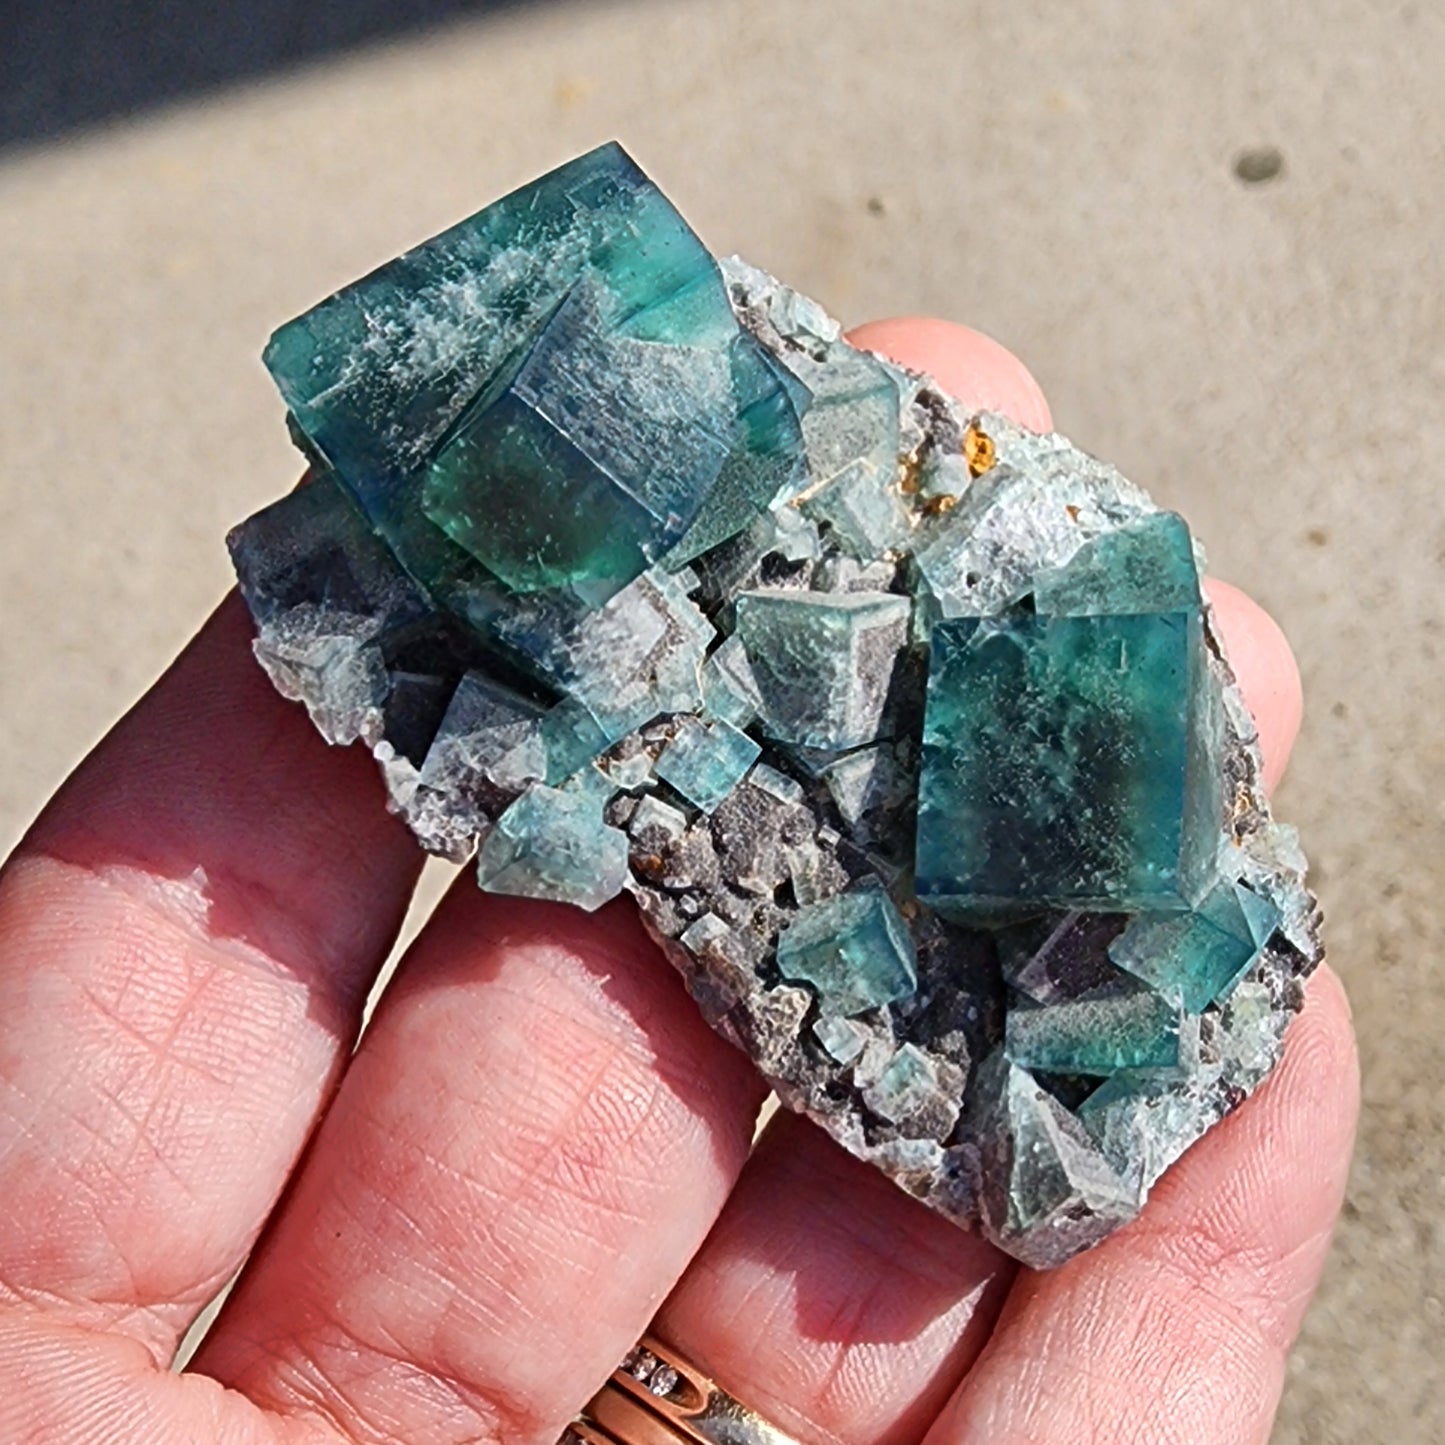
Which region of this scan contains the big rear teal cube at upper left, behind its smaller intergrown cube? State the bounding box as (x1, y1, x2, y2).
(266, 145, 736, 510)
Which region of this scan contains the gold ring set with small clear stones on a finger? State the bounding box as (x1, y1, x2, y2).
(559, 1335, 798, 1445)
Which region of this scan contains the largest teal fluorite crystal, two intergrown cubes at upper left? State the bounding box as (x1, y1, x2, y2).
(266, 145, 806, 597)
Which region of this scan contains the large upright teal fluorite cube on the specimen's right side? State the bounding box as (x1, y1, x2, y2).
(918, 519, 1220, 918)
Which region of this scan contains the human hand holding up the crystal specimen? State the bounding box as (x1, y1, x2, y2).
(0, 321, 1357, 1445)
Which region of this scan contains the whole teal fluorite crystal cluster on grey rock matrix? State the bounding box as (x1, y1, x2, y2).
(231, 146, 1319, 1266)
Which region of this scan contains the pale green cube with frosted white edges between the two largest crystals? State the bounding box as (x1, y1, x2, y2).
(736, 588, 909, 751)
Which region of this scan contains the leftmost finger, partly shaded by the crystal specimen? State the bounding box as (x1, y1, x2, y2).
(0, 595, 420, 1358)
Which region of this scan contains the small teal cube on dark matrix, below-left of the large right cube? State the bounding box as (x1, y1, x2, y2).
(777, 889, 918, 1017)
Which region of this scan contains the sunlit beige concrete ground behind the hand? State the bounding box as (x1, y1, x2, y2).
(0, 0, 1445, 1445)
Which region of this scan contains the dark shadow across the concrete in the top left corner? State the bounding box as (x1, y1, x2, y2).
(0, 0, 543, 147)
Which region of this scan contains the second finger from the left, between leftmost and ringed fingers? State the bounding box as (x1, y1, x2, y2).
(197, 877, 763, 1445)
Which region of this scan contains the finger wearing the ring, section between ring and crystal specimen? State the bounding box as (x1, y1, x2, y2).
(656, 1114, 1014, 1445)
